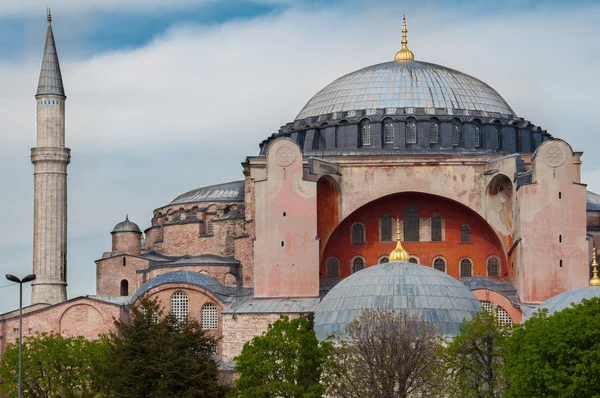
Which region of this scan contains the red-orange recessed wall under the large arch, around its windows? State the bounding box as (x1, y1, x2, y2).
(320, 192, 508, 278)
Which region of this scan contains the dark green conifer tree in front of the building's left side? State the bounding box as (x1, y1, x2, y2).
(99, 298, 226, 398)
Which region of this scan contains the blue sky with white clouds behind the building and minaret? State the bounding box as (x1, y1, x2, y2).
(0, 0, 600, 312)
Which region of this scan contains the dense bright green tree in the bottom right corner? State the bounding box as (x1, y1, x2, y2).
(506, 298, 600, 398)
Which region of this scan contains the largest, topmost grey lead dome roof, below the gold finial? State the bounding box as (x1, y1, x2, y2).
(296, 61, 515, 120)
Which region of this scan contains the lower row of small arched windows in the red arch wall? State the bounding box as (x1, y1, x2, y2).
(325, 256, 500, 278)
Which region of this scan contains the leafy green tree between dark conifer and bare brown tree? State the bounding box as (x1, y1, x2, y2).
(231, 314, 331, 398)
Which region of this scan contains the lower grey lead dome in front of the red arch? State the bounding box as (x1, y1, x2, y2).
(315, 261, 481, 339)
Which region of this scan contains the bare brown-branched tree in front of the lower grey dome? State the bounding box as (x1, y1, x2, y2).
(324, 309, 444, 398)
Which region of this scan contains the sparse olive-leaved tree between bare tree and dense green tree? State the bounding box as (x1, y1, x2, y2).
(444, 311, 509, 398)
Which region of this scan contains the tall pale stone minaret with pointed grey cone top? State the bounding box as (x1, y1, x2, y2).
(31, 9, 71, 304)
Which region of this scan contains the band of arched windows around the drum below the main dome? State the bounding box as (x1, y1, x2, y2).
(292, 119, 542, 153)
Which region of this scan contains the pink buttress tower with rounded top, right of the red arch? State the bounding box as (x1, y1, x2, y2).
(514, 140, 589, 303)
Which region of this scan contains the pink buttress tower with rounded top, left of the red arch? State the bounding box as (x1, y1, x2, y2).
(250, 138, 319, 297)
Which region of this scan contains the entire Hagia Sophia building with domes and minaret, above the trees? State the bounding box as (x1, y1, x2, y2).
(0, 11, 600, 366)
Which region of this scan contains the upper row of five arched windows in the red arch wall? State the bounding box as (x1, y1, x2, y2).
(351, 213, 471, 245)
